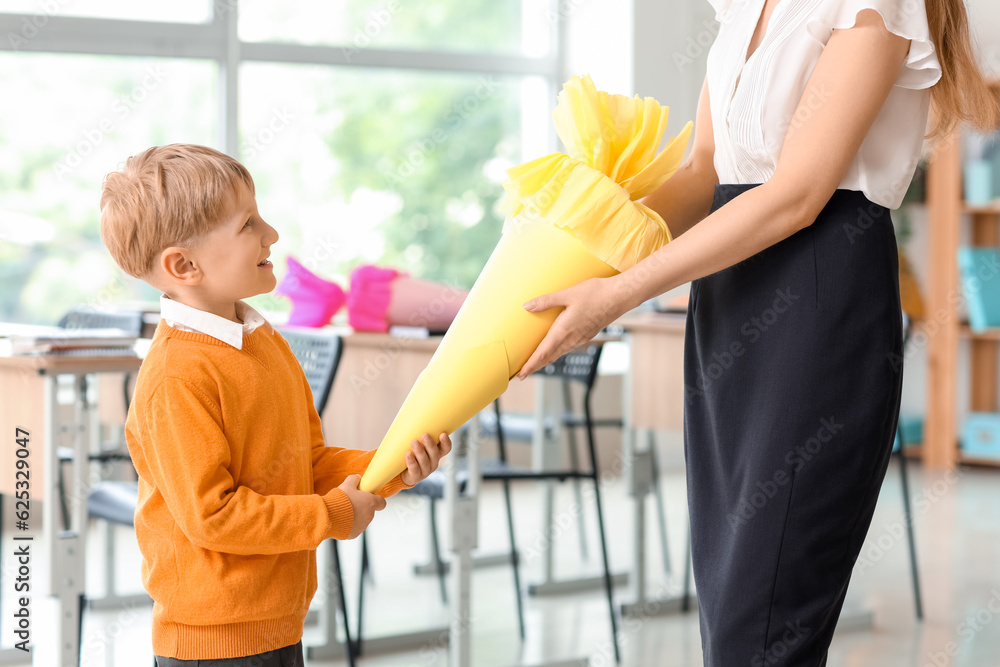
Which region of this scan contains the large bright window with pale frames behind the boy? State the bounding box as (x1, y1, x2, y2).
(0, 0, 560, 323)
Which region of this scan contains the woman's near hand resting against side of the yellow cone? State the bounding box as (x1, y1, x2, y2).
(517, 276, 632, 380)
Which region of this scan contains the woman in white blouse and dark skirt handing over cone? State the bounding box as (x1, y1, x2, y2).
(519, 0, 1000, 667)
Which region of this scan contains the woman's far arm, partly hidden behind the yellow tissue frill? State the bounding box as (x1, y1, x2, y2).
(642, 79, 719, 238)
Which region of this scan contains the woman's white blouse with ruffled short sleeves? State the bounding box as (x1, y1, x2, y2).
(707, 0, 941, 209)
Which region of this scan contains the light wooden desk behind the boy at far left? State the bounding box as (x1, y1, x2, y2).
(0, 355, 140, 667)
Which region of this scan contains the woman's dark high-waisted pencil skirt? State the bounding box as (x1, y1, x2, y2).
(684, 184, 903, 667)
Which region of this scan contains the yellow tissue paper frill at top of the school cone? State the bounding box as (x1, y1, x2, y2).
(503, 76, 693, 271)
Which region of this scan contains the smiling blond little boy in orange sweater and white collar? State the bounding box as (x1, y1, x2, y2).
(101, 144, 451, 667)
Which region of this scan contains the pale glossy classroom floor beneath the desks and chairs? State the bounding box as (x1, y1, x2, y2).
(0, 443, 1000, 667)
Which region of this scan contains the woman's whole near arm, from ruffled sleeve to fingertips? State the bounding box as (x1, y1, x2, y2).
(518, 9, 910, 378)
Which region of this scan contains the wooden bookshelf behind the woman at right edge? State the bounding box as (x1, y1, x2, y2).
(920, 81, 1000, 468)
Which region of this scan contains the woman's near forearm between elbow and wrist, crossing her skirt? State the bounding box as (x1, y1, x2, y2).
(611, 178, 815, 311)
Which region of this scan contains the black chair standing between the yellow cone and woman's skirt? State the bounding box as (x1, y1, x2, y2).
(404, 343, 621, 662)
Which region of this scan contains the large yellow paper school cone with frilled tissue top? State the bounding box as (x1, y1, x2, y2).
(359, 76, 692, 492)
